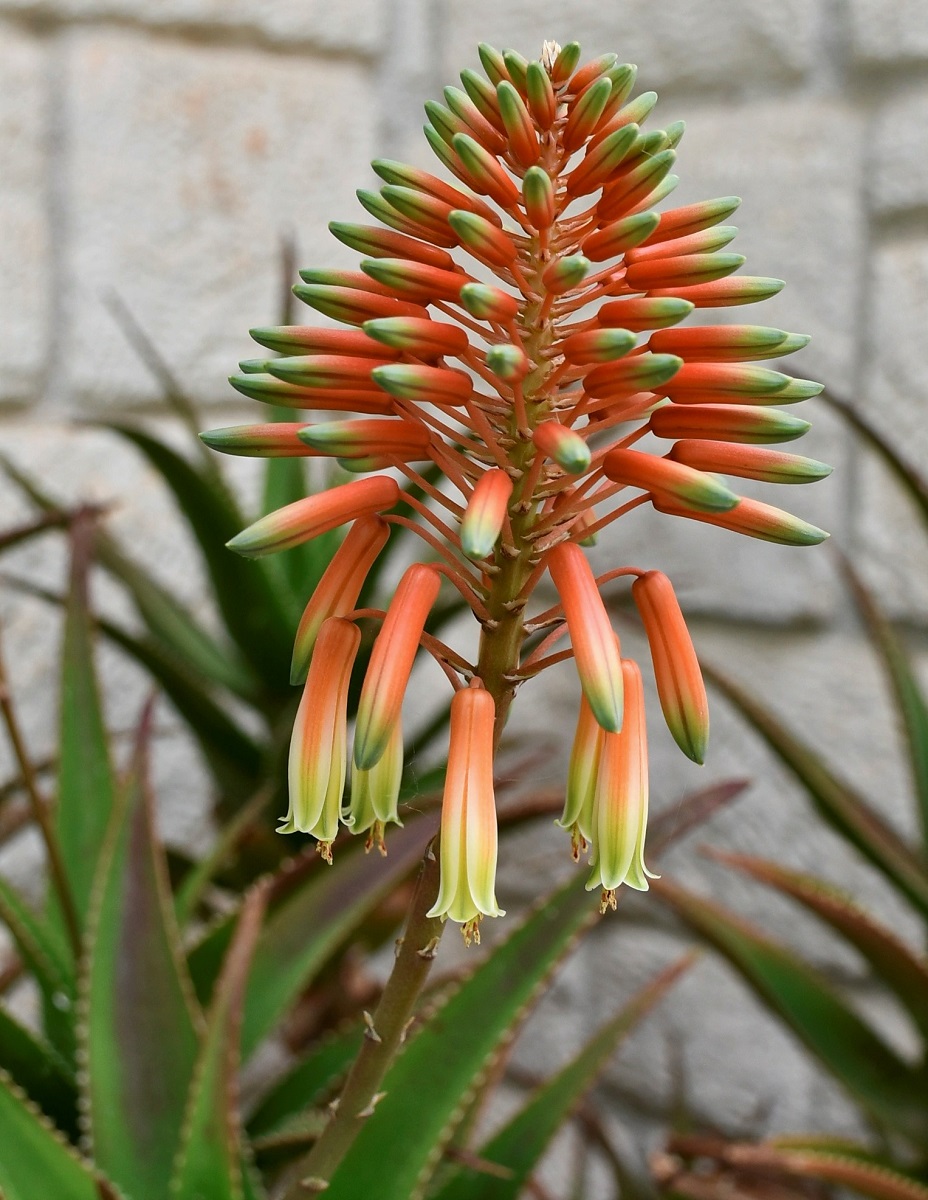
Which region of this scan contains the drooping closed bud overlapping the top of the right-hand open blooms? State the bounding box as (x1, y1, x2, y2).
(547, 542, 622, 733)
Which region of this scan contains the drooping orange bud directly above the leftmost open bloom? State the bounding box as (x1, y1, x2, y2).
(291, 517, 390, 684)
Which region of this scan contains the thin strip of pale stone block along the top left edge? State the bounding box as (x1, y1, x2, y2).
(0, 0, 387, 54)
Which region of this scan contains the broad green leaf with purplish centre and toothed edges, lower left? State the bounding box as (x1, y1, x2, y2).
(82, 707, 199, 1200)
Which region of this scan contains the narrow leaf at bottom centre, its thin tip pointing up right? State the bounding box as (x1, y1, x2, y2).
(433, 954, 694, 1200)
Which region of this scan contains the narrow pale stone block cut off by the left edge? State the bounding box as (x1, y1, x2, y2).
(0, 24, 52, 401)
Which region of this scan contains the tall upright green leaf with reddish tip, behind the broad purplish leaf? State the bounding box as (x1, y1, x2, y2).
(49, 522, 115, 926)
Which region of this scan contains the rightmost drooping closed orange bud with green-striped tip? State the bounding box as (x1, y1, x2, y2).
(631, 571, 708, 763)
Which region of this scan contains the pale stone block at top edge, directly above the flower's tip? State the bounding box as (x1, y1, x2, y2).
(445, 0, 819, 89)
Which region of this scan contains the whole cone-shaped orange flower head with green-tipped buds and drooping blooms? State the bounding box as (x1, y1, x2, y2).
(204, 43, 828, 935)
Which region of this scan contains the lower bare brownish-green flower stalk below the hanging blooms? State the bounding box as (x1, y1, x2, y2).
(283, 845, 443, 1200)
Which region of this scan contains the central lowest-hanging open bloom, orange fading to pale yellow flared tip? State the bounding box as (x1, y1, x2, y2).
(429, 688, 505, 942)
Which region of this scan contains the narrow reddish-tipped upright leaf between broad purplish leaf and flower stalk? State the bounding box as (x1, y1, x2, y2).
(172, 884, 267, 1200)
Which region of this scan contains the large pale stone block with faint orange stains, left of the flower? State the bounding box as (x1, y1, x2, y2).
(62, 30, 375, 408)
